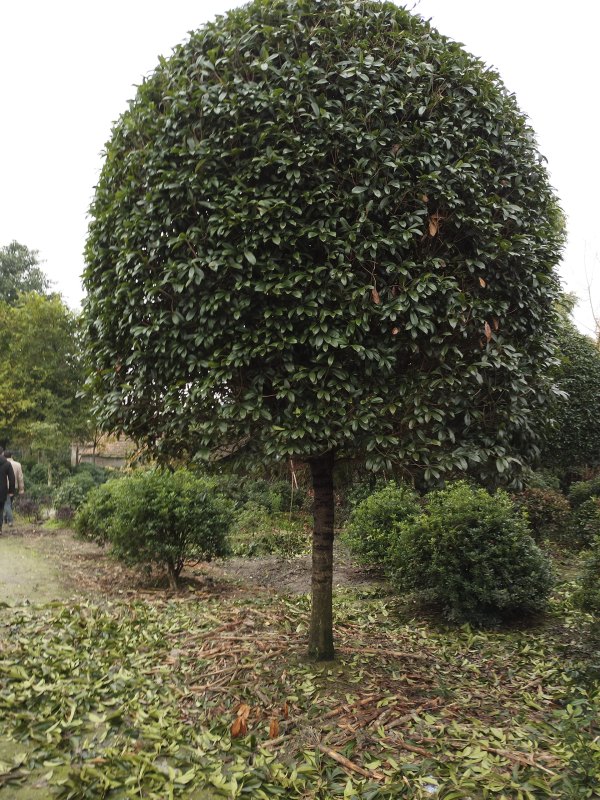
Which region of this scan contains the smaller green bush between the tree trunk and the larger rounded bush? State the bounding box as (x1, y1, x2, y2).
(344, 482, 421, 566)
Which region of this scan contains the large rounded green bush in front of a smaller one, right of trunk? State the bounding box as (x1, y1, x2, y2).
(393, 481, 552, 623)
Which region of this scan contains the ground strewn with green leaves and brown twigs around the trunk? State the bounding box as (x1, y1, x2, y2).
(0, 532, 600, 800)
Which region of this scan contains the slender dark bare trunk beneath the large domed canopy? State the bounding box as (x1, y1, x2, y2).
(308, 451, 334, 661)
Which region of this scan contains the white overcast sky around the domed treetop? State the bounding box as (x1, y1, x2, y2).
(0, 0, 600, 333)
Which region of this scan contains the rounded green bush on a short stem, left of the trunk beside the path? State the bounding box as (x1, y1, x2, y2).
(77, 470, 233, 588)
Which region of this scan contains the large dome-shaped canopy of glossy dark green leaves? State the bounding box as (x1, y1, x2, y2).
(85, 0, 562, 479)
